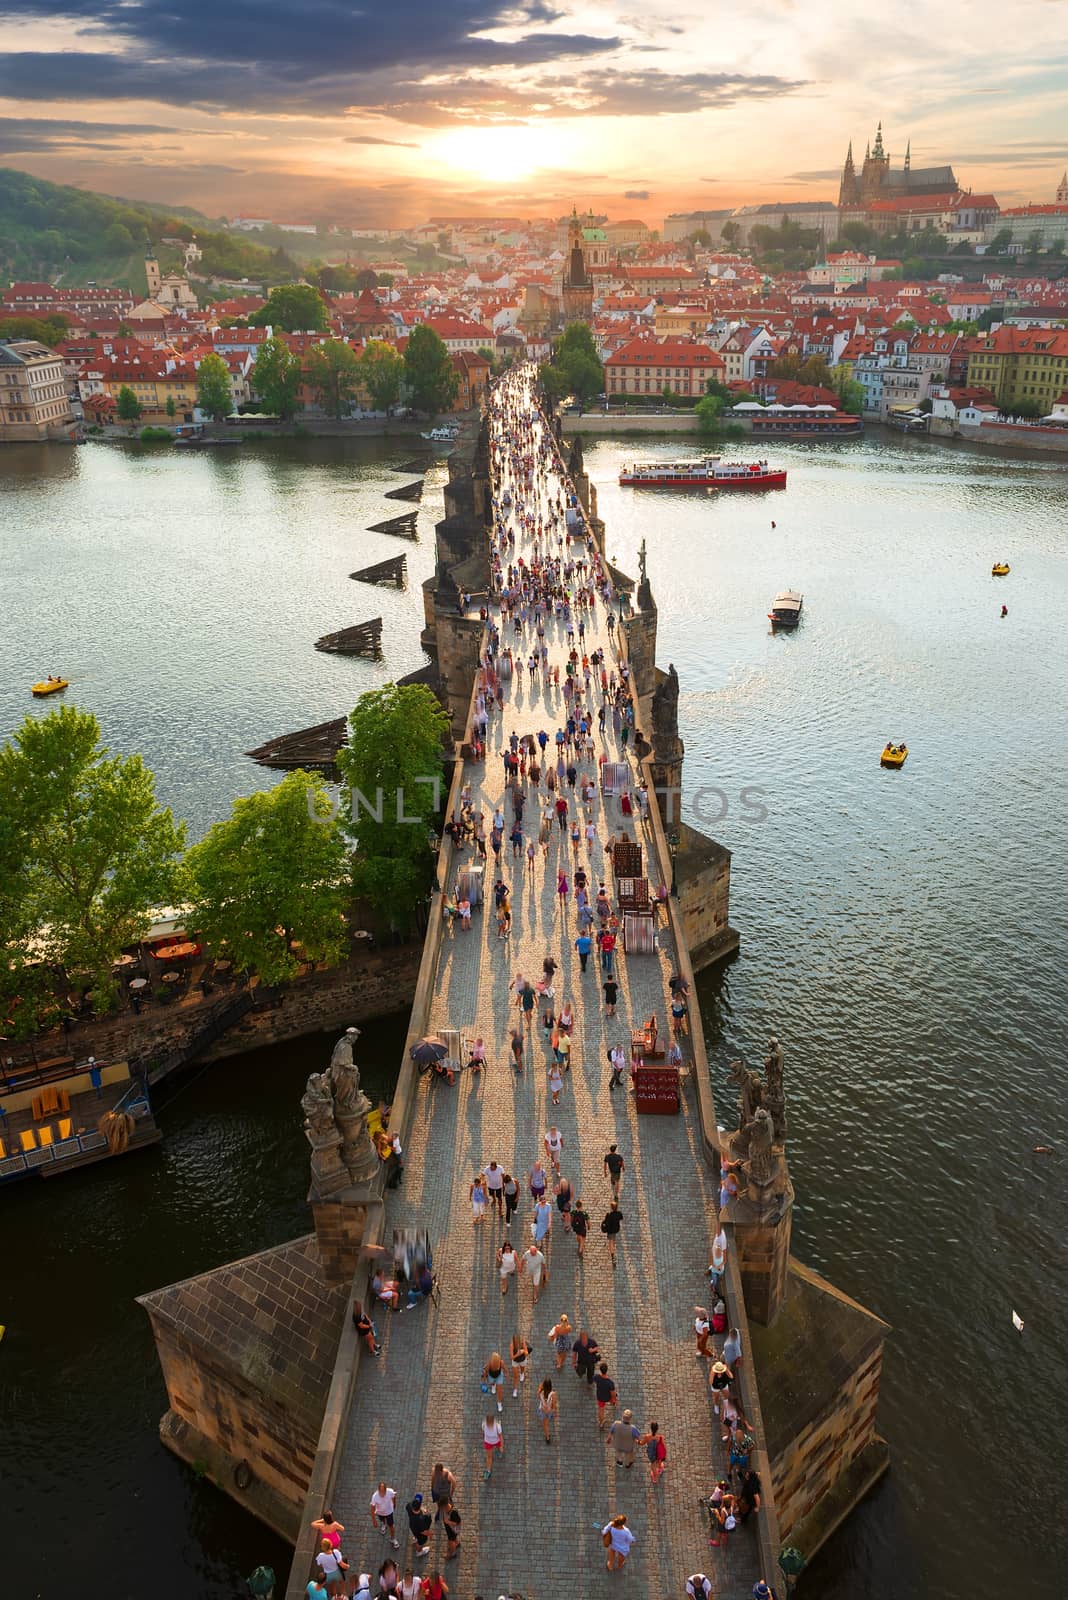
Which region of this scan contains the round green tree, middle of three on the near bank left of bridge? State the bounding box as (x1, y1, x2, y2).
(185, 771, 349, 984)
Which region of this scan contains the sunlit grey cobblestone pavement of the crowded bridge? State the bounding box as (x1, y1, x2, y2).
(334, 387, 758, 1600)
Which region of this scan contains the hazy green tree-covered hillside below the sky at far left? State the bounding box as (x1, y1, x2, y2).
(0, 166, 296, 293)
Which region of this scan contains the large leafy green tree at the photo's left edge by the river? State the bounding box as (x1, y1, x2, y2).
(0, 706, 185, 978)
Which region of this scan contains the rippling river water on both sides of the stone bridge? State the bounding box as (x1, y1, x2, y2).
(0, 435, 1068, 1600)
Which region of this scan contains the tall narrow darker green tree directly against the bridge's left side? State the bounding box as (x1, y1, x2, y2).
(337, 683, 448, 928)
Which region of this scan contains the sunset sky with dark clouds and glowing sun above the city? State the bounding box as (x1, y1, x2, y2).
(0, 0, 1068, 227)
